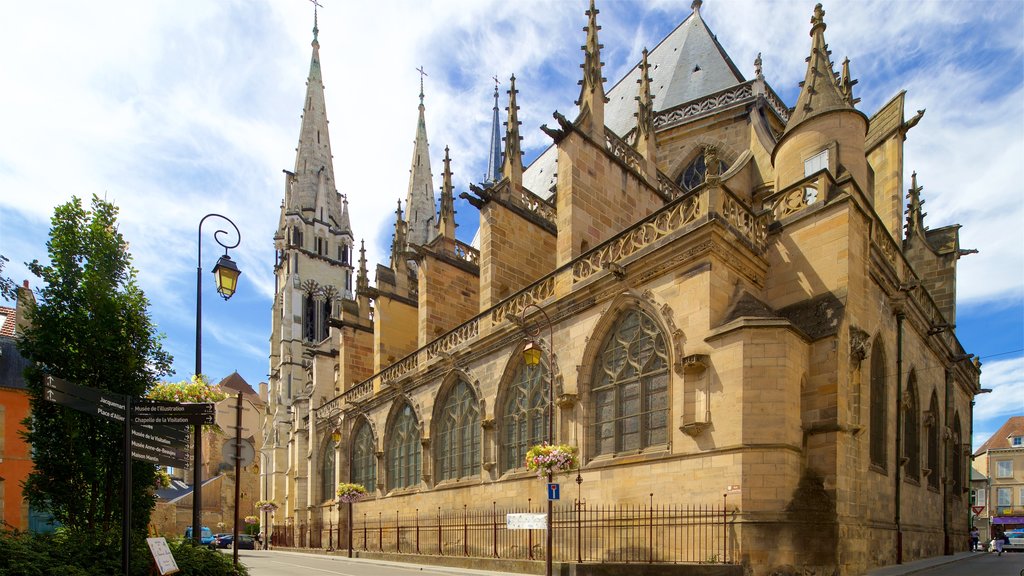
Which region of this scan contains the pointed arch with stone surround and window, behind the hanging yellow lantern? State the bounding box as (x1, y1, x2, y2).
(495, 342, 551, 472)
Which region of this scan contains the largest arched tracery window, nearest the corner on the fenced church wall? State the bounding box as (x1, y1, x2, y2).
(591, 310, 669, 454)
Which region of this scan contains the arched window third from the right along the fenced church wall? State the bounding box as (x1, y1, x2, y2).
(434, 380, 480, 481)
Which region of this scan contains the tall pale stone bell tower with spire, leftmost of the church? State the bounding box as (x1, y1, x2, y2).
(264, 15, 354, 516)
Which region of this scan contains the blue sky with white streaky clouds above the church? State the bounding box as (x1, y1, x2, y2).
(0, 0, 1024, 446)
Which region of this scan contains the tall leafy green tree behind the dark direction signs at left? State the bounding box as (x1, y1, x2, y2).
(18, 196, 171, 533)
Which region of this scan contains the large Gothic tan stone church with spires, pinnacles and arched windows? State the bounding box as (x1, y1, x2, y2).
(260, 0, 980, 575)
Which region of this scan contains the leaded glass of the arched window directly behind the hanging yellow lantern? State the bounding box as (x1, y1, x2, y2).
(502, 359, 550, 470)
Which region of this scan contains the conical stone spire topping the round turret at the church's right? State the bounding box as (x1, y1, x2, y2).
(785, 4, 853, 132)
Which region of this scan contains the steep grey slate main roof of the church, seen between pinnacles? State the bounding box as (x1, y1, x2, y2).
(522, 3, 745, 199)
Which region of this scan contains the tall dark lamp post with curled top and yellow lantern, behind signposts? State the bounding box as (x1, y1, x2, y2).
(193, 213, 242, 544)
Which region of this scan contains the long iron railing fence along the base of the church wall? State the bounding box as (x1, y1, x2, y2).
(270, 496, 734, 564)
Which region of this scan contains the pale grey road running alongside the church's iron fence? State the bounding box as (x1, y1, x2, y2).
(228, 550, 519, 576)
